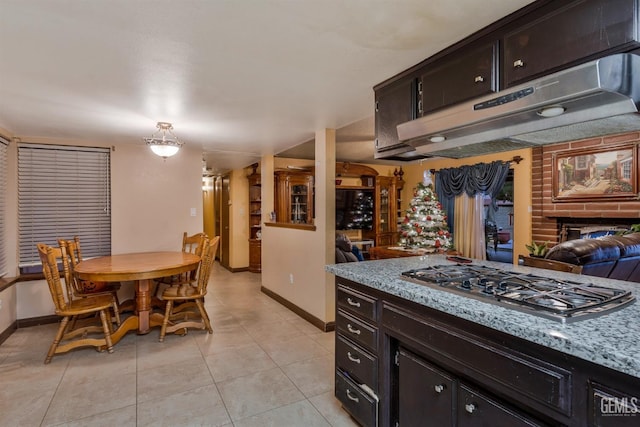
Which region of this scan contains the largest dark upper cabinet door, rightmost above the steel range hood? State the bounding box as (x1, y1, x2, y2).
(503, 0, 639, 87)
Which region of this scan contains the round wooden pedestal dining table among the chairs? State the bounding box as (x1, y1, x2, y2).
(74, 252, 200, 343)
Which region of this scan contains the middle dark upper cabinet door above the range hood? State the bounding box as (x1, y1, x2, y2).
(417, 41, 498, 116)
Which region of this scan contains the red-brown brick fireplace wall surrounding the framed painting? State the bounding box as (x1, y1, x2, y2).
(532, 132, 640, 243)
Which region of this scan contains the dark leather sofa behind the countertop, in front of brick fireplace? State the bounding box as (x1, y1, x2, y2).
(545, 233, 640, 282)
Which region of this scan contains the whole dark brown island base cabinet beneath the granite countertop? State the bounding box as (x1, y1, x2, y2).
(335, 277, 640, 427)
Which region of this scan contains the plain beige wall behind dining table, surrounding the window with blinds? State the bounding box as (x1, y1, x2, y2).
(8, 141, 203, 320)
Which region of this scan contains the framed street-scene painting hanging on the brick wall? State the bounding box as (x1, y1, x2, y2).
(552, 144, 638, 202)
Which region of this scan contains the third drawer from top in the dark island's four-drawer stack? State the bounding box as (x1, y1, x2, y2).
(336, 334, 378, 392)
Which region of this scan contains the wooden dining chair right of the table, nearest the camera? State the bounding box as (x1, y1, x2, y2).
(160, 236, 220, 342)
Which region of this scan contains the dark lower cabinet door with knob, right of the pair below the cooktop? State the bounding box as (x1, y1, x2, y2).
(457, 384, 544, 427)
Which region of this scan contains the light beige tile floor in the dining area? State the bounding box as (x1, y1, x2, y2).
(0, 264, 356, 427)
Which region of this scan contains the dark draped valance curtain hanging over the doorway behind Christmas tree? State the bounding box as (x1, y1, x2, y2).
(436, 161, 510, 234)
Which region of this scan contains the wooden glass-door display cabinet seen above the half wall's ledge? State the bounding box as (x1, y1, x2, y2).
(274, 171, 315, 224)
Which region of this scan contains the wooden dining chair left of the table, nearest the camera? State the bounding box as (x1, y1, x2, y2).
(37, 243, 113, 364)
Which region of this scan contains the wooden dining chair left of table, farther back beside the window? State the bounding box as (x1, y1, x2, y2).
(58, 236, 121, 326)
